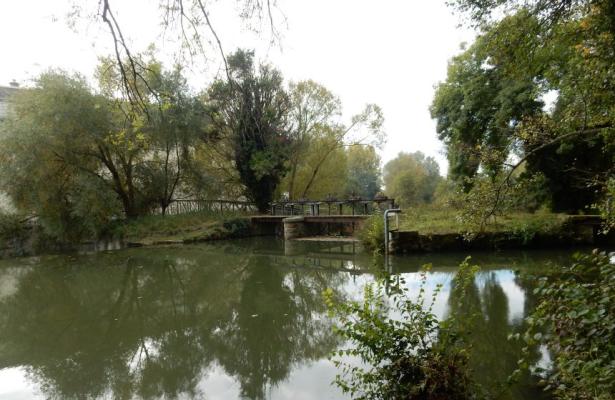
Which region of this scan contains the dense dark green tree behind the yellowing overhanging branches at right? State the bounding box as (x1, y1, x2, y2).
(431, 36, 543, 190)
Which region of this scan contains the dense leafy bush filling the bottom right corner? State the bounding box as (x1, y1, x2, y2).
(515, 250, 615, 400)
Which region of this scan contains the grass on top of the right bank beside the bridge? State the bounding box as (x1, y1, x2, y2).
(399, 206, 568, 234)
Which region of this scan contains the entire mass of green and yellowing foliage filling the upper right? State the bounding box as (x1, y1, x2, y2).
(432, 0, 615, 217)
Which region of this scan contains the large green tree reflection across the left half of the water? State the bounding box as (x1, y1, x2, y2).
(0, 241, 347, 399)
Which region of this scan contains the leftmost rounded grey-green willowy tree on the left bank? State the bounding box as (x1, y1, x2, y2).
(0, 72, 121, 239)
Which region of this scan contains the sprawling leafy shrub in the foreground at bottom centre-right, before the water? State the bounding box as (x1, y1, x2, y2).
(325, 260, 481, 399)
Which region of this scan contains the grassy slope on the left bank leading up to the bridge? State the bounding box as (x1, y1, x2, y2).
(113, 211, 251, 245)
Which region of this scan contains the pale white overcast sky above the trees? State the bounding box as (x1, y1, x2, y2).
(0, 0, 475, 174)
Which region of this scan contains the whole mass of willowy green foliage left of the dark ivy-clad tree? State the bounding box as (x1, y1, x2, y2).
(0, 59, 208, 241)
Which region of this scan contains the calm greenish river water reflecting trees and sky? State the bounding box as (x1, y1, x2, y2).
(0, 239, 569, 399)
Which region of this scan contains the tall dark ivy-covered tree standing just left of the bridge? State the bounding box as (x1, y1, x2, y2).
(208, 50, 292, 212)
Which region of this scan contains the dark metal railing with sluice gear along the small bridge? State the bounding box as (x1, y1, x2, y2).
(270, 197, 395, 215)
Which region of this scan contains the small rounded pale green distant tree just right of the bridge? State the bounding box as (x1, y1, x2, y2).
(384, 151, 443, 207)
